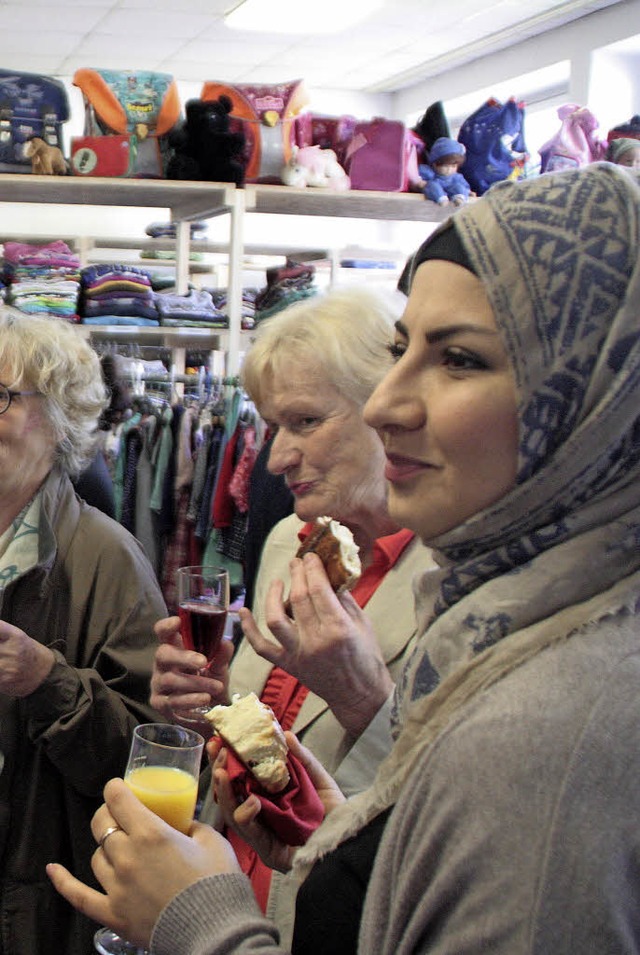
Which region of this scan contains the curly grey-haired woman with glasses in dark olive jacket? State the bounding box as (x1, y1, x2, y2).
(0, 308, 166, 955)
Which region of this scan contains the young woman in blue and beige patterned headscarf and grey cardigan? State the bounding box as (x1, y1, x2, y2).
(51, 164, 640, 955)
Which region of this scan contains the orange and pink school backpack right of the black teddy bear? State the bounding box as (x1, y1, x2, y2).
(201, 80, 308, 183)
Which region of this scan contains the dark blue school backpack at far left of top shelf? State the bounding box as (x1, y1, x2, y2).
(0, 70, 69, 173)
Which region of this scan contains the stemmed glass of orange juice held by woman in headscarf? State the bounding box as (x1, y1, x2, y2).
(94, 723, 204, 955)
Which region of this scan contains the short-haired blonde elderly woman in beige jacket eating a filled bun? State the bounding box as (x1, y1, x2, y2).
(151, 287, 430, 938)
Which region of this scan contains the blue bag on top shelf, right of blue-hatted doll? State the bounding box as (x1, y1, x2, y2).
(458, 98, 528, 196)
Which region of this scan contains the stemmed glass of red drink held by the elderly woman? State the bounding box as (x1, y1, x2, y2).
(176, 565, 230, 722)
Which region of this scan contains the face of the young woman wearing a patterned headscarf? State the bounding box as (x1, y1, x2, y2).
(364, 260, 518, 541)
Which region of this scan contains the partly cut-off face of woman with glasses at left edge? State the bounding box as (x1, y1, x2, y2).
(0, 368, 56, 502)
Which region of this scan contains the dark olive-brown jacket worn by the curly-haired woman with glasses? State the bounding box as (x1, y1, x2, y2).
(0, 472, 166, 955)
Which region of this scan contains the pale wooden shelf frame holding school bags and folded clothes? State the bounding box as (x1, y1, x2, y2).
(0, 174, 451, 375)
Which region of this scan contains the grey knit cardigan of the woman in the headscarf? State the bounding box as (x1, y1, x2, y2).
(152, 613, 640, 955)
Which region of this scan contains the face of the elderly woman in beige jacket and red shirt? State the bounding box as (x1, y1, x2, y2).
(260, 363, 387, 526)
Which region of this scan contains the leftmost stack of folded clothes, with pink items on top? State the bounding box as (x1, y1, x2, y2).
(4, 240, 80, 322)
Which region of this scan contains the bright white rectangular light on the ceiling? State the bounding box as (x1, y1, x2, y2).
(224, 0, 384, 36)
